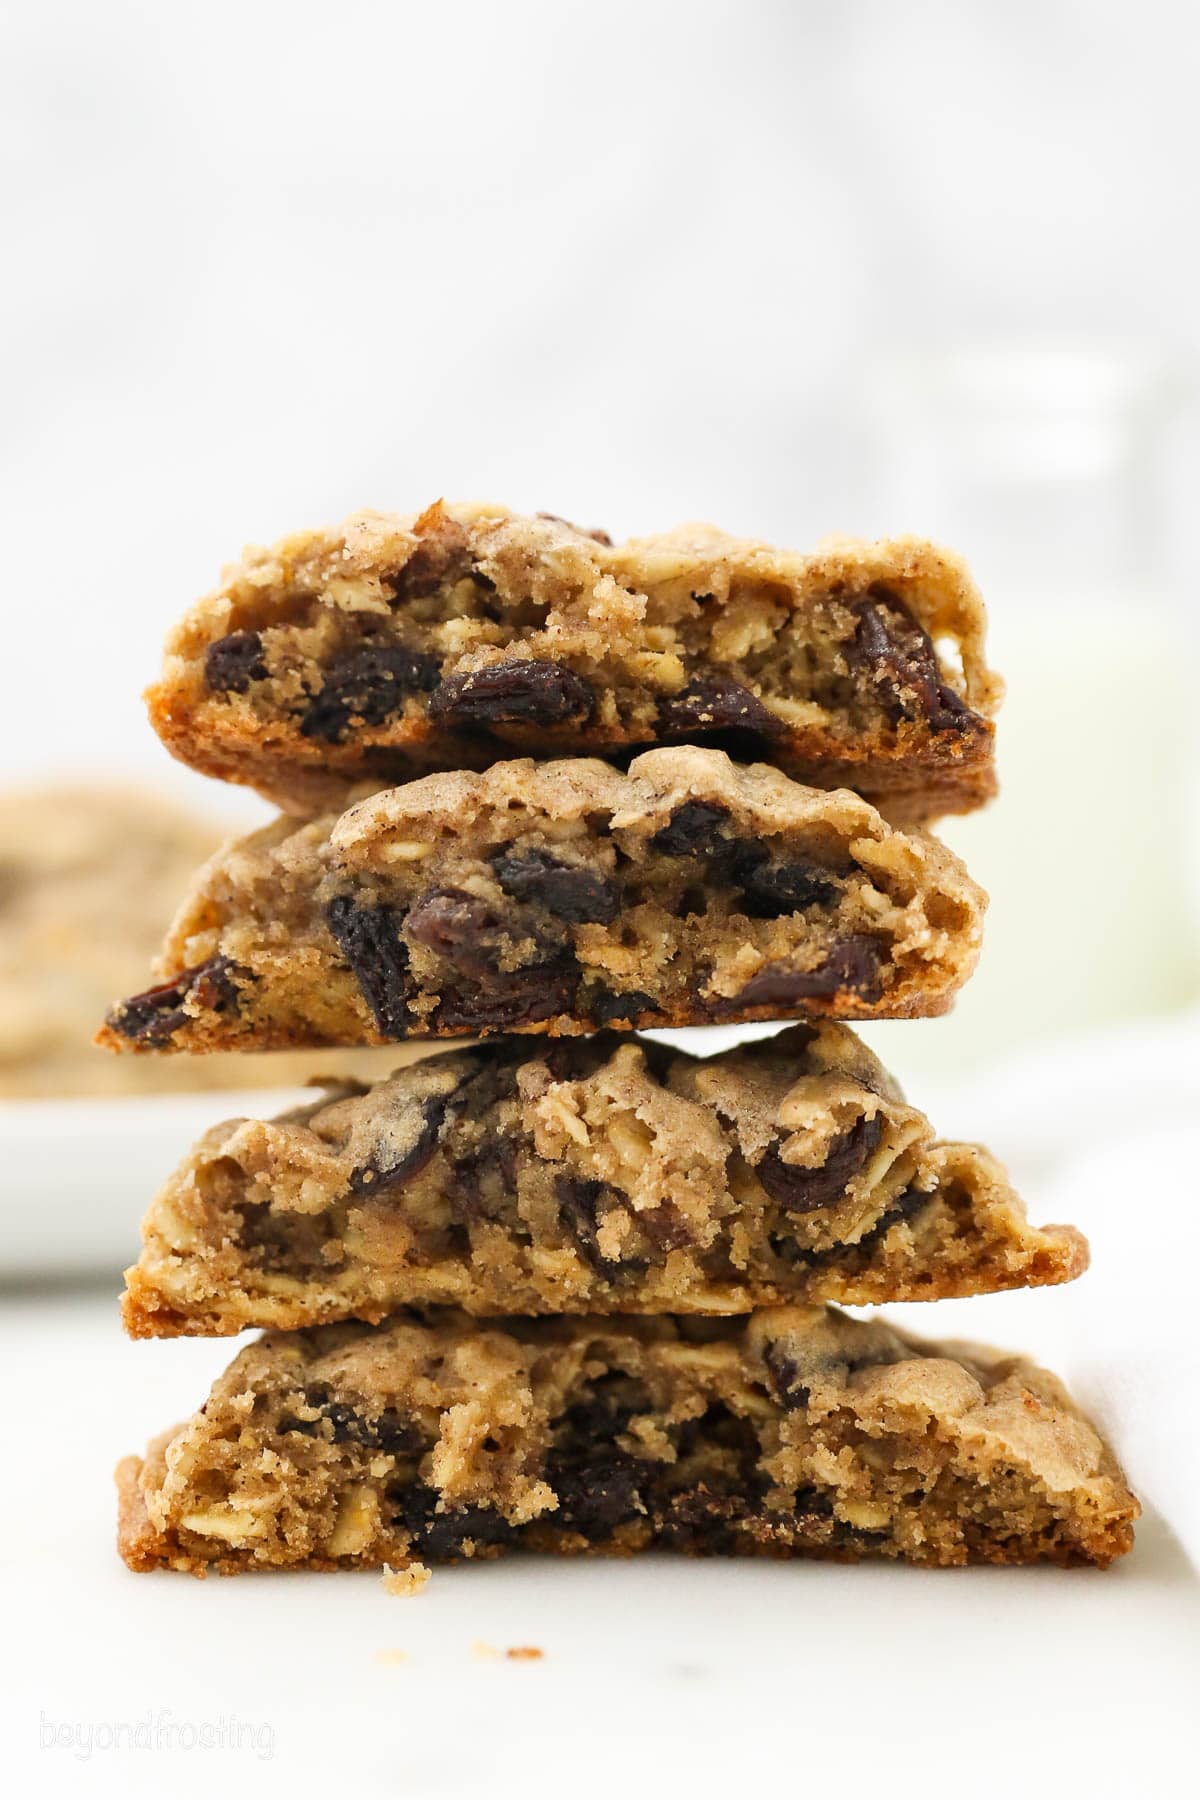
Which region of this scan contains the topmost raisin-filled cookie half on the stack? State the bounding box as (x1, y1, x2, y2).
(148, 502, 1000, 821)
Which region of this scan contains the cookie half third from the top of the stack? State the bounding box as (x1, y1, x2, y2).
(124, 1024, 1087, 1336)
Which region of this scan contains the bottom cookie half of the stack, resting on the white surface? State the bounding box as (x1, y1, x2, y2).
(117, 1307, 1137, 1573)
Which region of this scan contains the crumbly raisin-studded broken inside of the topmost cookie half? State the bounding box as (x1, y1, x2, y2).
(205, 550, 979, 745)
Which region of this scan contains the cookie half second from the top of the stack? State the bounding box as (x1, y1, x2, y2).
(101, 747, 986, 1051)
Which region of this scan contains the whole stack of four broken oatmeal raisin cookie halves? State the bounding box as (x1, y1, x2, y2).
(101, 504, 1137, 1584)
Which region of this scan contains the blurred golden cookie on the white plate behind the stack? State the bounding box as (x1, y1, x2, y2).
(0, 785, 408, 1100)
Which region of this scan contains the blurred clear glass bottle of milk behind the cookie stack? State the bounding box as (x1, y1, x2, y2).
(852, 347, 1200, 1093)
